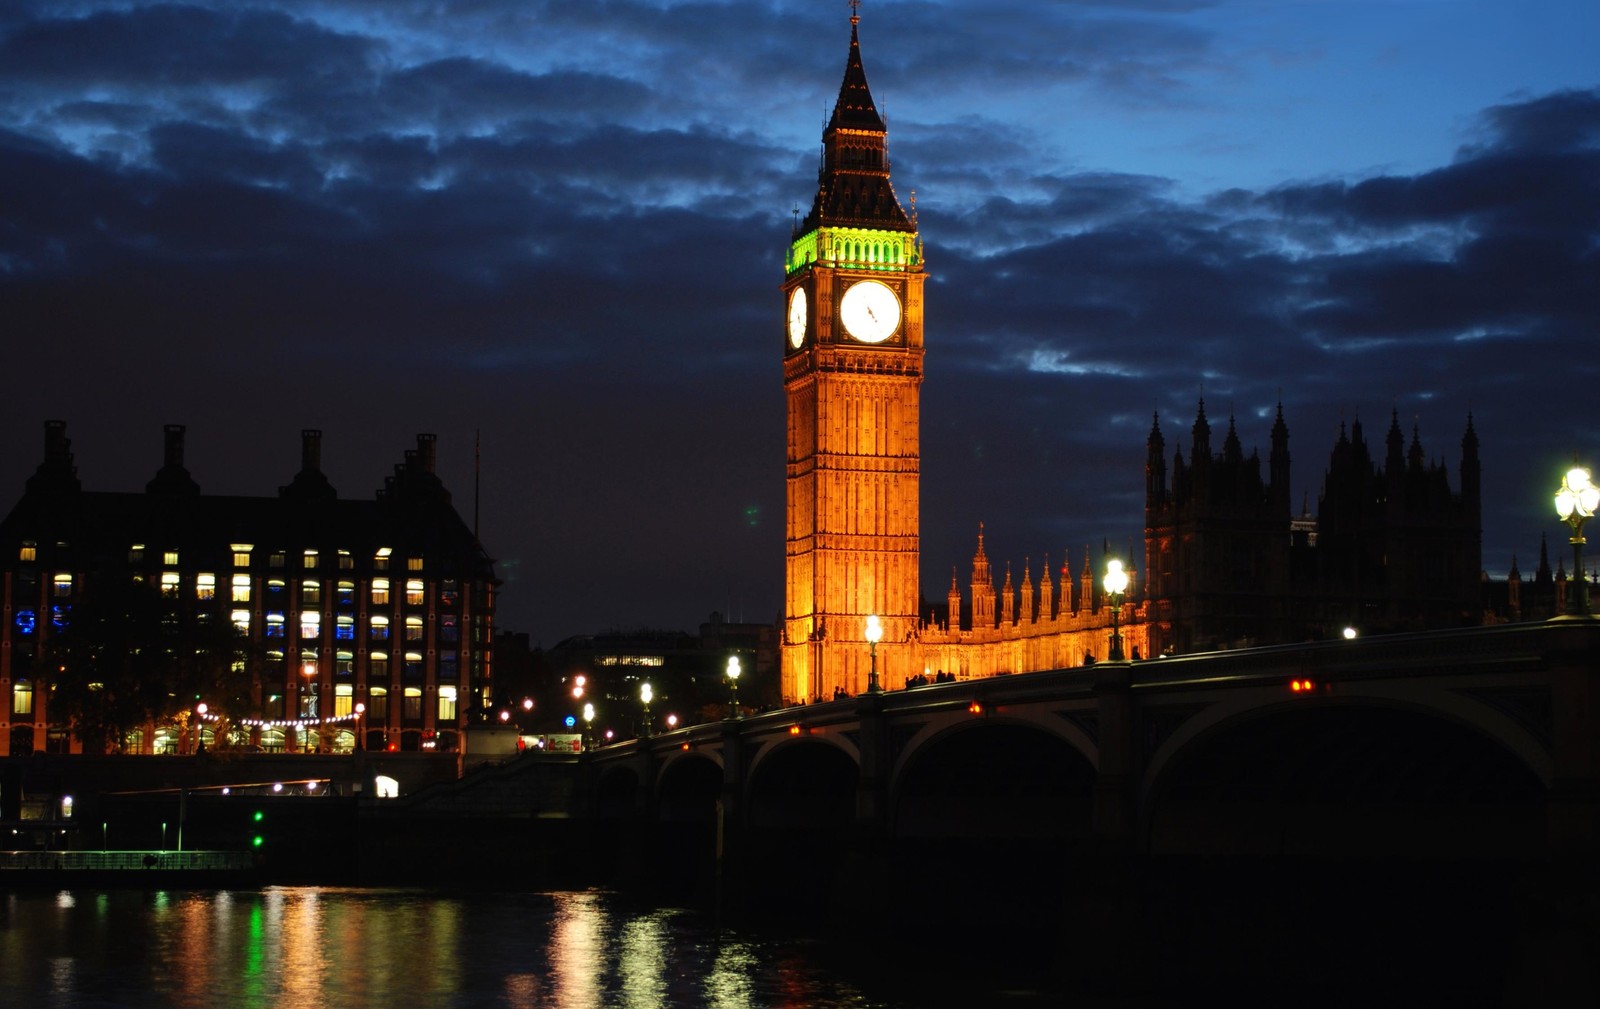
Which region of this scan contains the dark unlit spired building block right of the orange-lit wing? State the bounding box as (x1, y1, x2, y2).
(1144, 401, 1485, 652)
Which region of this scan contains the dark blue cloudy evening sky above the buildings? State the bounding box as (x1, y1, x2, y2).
(0, 0, 1600, 646)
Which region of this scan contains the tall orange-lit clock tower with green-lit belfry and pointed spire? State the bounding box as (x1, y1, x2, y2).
(782, 3, 923, 702)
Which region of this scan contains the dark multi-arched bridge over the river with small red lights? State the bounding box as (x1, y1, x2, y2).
(586, 620, 1600, 1004)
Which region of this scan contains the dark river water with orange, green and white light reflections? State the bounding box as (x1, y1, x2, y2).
(0, 887, 906, 1009)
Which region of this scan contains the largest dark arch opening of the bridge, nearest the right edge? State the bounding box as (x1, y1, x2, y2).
(1141, 692, 1549, 859)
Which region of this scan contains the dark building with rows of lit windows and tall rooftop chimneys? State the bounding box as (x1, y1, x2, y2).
(0, 421, 498, 755)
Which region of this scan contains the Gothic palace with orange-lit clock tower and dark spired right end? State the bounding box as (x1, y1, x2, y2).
(781, 16, 1485, 702)
